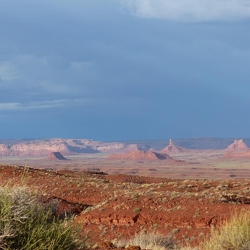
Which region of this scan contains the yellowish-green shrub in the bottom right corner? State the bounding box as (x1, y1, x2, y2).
(203, 212, 250, 250)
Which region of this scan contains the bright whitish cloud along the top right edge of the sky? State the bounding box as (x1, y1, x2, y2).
(122, 0, 250, 22)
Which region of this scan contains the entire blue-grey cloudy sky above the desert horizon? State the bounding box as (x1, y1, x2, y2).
(0, 0, 250, 141)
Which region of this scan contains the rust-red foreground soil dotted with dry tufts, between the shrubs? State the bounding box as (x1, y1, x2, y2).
(0, 166, 250, 249)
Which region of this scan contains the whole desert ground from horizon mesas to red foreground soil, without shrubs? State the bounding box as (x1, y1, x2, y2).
(0, 138, 250, 249)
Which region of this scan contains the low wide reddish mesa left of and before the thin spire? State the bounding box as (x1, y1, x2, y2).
(108, 150, 174, 161)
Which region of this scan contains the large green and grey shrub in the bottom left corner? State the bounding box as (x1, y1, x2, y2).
(0, 187, 87, 250)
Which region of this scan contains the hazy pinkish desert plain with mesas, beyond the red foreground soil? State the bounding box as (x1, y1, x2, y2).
(0, 138, 250, 179)
